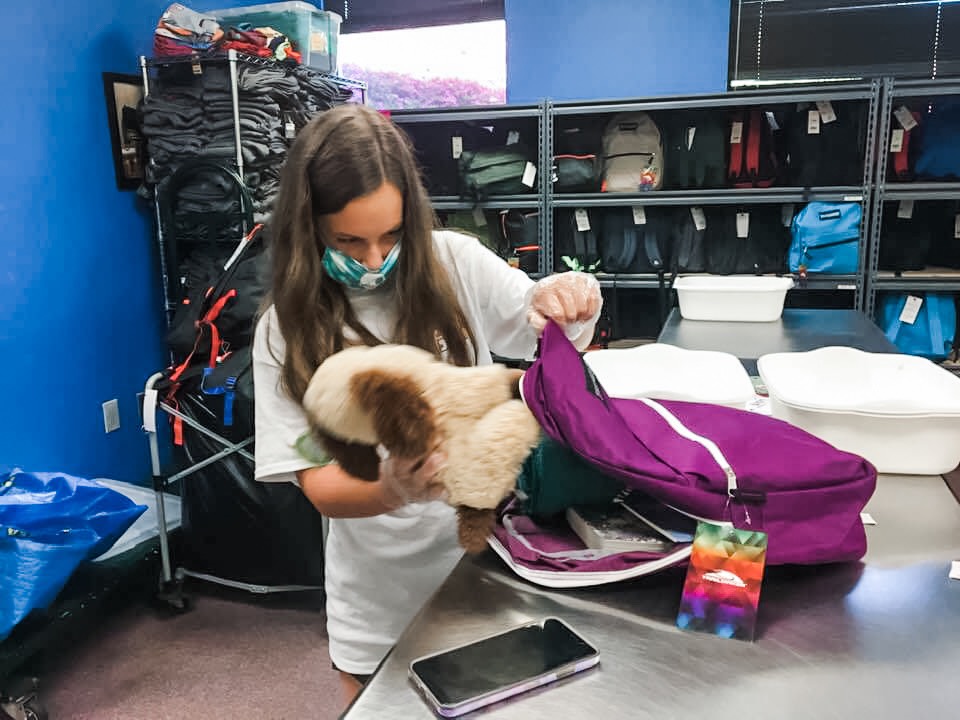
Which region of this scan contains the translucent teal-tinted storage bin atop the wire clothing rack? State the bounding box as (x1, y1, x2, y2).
(206, 0, 342, 75)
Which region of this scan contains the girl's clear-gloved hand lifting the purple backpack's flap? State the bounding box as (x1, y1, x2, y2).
(527, 271, 603, 350)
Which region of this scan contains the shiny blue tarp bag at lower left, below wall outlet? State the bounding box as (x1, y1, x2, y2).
(0, 468, 147, 640)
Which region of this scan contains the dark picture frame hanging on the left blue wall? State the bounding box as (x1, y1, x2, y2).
(103, 72, 146, 190)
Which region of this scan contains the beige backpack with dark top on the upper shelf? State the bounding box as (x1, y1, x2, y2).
(601, 112, 663, 192)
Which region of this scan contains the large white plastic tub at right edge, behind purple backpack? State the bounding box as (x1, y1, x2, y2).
(757, 347, 960, 475)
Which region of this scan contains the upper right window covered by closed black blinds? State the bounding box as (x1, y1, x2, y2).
(729, 0, 960, 87)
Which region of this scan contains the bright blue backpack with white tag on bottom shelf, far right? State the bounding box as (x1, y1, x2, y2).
(877, 293, 957, 361)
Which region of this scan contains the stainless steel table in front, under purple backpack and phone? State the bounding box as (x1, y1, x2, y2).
(344, 476, 960, 720)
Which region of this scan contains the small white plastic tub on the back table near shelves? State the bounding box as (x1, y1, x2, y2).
(673, 275, 793, 322)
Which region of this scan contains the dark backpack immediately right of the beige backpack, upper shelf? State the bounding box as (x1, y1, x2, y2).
(661, 110, 727, 189)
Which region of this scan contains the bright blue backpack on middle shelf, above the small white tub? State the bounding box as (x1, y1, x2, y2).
(787, 202, 863, 275)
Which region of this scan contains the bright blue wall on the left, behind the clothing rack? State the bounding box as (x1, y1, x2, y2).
(0, 0, 167, 482)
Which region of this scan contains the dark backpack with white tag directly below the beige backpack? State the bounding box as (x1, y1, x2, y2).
(599, 207, 671, 273)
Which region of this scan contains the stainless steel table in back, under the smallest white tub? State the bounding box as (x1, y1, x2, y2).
(657, 308, 899, 375)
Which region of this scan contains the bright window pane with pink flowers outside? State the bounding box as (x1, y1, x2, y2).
(338, 20, 507, 109)
